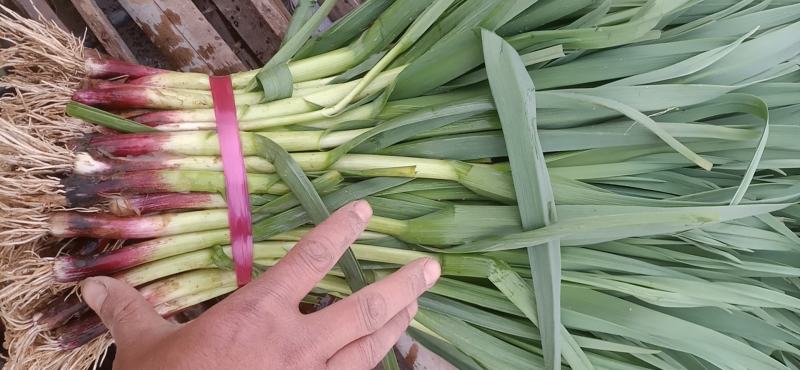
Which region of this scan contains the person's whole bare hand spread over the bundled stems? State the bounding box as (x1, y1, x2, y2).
(81, 201, 441, 370)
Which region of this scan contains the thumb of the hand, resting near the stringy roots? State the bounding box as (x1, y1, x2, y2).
(81, 276, 169, 344)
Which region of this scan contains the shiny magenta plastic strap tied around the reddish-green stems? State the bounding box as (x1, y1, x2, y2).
(209, 76, 253, 286)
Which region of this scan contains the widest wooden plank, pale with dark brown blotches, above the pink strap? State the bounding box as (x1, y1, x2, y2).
(119, 0, 247, 74)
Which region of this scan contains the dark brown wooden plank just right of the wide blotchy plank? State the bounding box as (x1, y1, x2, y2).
(212, 0, 281, 64)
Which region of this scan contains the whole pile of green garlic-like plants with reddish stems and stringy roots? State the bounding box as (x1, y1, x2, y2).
(0, 0, 800, 369)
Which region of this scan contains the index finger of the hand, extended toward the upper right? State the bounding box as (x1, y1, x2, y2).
(246, 200, 372, 306)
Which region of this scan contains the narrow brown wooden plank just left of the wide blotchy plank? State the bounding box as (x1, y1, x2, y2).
(71, 0, 138, 63)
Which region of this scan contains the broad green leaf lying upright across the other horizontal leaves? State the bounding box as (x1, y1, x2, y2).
(481, 29, 561, 369)
